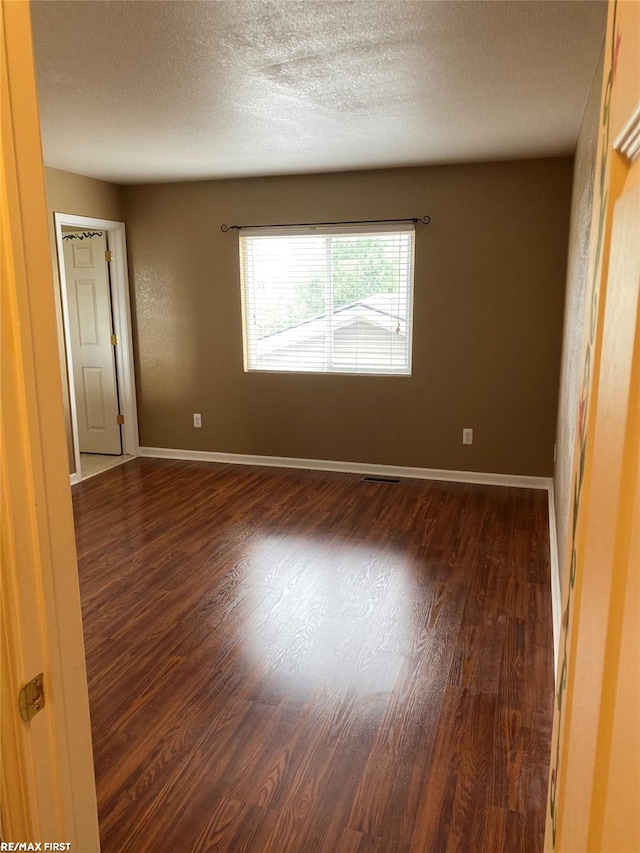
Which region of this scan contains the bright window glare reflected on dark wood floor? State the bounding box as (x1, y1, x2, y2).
(242, 535, 415, 696)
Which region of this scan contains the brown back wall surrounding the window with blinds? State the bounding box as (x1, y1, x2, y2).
(122, 158, 572, 475)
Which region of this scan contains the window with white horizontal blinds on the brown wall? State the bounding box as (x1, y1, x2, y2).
(240, 224, 414, 375)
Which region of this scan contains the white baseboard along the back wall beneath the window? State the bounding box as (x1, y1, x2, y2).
(140, 447, 551, 491)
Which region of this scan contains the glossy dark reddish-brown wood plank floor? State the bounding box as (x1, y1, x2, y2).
(73, 459, 553, 853)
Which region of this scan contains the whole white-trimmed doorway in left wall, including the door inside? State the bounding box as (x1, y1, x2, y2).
(54, 213, 139, 485)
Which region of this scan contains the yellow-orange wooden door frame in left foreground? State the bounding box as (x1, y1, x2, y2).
(0, 0, 100, 853)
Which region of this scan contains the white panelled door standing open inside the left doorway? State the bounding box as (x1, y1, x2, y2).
(62, 226, 122, 456)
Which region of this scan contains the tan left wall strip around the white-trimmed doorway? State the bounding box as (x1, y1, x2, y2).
(45, 168, 123, 474)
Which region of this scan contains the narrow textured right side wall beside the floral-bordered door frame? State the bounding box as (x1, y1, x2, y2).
(553, 49, 604, 583)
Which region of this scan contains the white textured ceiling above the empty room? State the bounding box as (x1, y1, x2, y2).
(32, 0, 606, 183)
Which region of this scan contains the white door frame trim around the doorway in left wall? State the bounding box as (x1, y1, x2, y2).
(53, 213, 140, 485)
